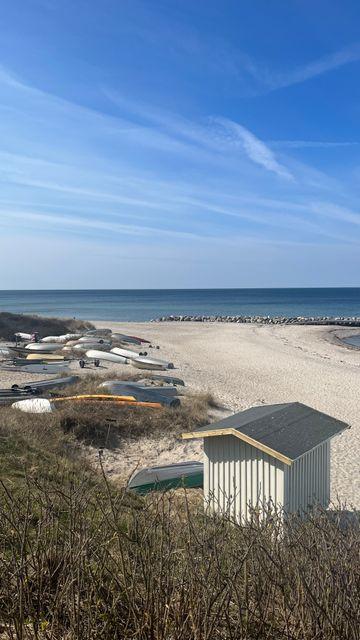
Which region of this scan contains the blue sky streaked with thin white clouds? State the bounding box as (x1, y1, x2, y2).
(0, 0, 360, 289)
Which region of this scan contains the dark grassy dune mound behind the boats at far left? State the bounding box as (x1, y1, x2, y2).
(0, 312, 94, 340)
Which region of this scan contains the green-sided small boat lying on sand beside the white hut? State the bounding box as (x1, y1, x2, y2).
(127, 462, 204, 494)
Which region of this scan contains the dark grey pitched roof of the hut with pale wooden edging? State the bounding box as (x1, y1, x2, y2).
(182, 402, 349, 464)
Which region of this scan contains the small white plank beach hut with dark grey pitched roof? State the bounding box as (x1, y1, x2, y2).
(182, 402, 349, 521)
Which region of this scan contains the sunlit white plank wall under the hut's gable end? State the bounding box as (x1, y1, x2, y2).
(204, 436, 284, 521)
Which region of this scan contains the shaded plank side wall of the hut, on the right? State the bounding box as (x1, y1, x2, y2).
(284, 441, 330, 513)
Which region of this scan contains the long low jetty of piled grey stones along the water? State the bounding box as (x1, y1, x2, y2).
(151, 315, 360, 327)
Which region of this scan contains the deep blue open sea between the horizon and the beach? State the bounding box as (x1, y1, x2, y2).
(0, 287, 360, 322)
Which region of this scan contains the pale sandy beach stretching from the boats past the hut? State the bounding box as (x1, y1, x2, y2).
(0, 321, 360, 508)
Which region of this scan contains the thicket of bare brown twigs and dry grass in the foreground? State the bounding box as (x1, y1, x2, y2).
(0, 464, 360, 640)
